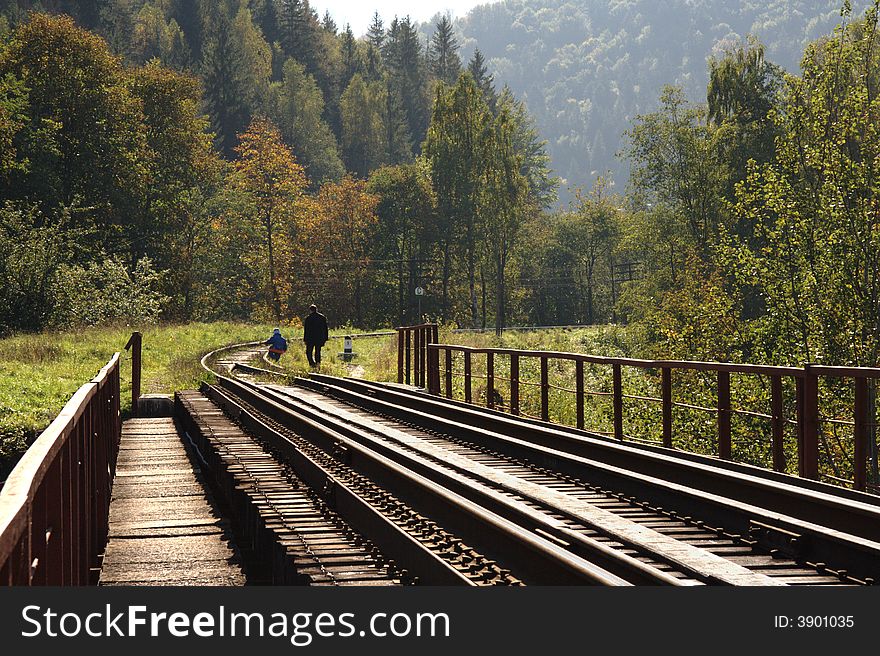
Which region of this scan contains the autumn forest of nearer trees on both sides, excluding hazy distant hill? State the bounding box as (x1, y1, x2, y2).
(0, 0, 880, 376)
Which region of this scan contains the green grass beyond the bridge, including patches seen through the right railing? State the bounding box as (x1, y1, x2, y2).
(0, 323, 852, 480)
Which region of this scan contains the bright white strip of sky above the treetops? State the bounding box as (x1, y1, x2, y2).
(309, 0, 497, 36)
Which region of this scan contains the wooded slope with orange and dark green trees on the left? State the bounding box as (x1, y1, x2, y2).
(0, 0, 556, 333)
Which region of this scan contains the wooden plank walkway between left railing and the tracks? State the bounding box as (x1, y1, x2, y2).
(100, 418, 245, 586)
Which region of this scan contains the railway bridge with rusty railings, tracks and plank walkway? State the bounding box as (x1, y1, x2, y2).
(0, 325, 880, 586)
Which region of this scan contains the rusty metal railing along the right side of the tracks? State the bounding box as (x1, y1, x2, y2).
(424, 346, 880, 491)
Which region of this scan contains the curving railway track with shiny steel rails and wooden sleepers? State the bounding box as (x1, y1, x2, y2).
(194, 345, 880, 586)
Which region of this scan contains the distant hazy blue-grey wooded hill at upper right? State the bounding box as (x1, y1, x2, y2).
(454, 0, 870, 200)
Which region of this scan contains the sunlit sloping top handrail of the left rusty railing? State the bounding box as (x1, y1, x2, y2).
(0, 353, 119, 584)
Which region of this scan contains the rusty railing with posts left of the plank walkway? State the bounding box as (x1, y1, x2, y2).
(0, 353, 121, 586)
